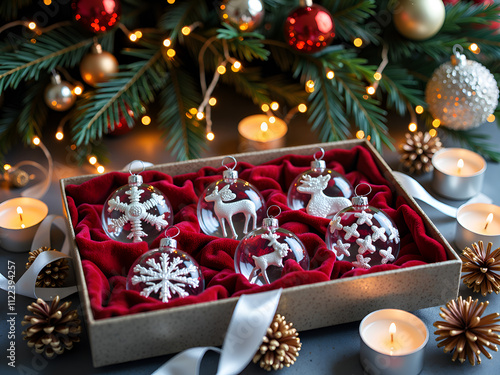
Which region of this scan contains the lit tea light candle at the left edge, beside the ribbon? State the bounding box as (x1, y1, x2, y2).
(0, 197, 49, 252)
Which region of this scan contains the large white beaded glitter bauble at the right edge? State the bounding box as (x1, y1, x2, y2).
(425, 51, 498, 130)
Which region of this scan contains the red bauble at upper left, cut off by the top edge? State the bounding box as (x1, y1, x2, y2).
(71, 0, 121, 33)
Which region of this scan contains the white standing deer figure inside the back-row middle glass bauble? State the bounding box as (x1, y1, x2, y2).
(205, 184, 257, 239)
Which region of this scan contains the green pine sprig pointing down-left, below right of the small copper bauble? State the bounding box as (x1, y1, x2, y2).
(72, 50, 165, 146)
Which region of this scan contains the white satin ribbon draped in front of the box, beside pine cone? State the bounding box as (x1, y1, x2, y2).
(152, 289, 282, 375)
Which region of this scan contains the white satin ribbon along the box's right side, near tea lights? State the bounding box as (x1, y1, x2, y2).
(392, 171, 492, 218)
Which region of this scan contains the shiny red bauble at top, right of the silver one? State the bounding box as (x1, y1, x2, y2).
(285, 4, 335, 53)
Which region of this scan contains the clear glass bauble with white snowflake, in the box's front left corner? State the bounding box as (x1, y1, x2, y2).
(127, 227, 205, 303)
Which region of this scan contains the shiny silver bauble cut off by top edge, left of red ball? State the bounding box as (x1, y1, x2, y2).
(219, 0, 265, 31)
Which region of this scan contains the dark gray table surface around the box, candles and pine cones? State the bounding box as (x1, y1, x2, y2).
(0, 95, 500, 375)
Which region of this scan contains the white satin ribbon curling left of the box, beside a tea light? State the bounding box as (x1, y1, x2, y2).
(0, 215, 77, 301)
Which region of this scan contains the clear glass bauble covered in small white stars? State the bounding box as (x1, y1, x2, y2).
(326, 184, 400, 269)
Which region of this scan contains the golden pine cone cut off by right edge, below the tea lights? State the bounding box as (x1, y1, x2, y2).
(460, 241, 500, 296)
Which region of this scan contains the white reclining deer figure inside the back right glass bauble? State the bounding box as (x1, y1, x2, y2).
(297, 174, 352, 217)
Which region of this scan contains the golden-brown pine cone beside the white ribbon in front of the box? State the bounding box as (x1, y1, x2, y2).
(253, 314, 302, 371)
